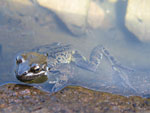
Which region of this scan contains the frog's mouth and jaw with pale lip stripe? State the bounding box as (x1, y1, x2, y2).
(16, 71, 47, 83)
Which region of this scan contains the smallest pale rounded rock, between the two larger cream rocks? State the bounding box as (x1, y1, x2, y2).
(87, 2, 105, 29)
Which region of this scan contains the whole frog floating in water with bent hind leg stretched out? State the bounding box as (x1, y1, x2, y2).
(15, 42, 135, 92)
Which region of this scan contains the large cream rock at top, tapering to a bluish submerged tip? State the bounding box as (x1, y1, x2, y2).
(37, 0, 91, 35)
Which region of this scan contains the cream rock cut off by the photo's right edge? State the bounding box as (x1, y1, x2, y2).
(125, 0, 150, 42)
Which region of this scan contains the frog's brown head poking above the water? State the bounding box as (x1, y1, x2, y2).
(16, 52, 49, 83)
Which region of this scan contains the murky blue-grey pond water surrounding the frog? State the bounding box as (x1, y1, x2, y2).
(0, 0, 150, 96)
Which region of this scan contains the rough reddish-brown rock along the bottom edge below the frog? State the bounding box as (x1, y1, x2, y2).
(0, 84, 150, 113)
